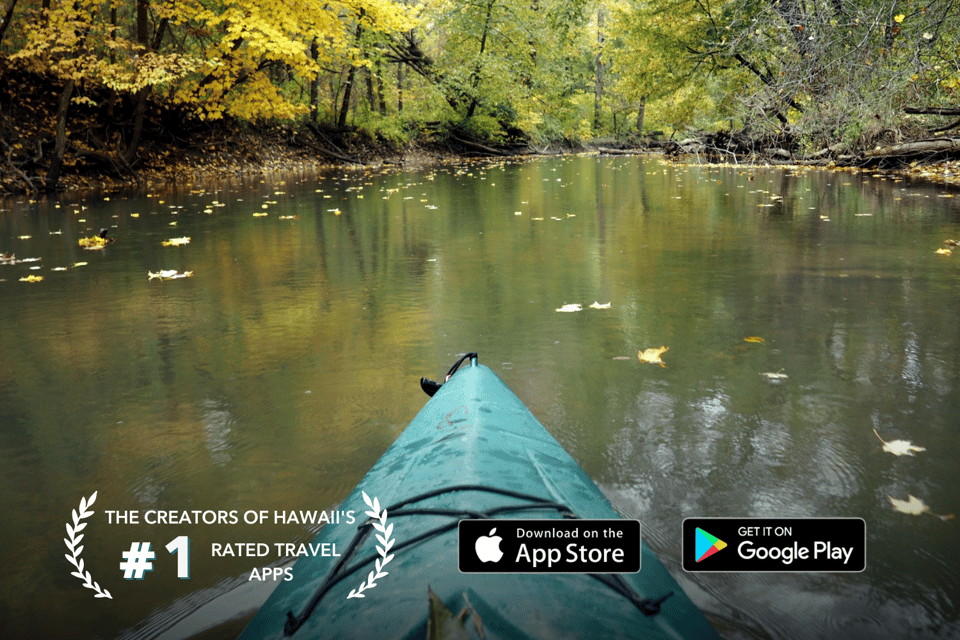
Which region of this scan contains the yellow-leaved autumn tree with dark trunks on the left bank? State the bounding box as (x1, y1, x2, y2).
(3, 0, 413, 188)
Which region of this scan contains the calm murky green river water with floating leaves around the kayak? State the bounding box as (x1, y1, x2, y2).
(0, 156, 960, 640)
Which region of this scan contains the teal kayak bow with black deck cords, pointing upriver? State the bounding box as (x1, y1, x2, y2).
(241, 354, 719, 640)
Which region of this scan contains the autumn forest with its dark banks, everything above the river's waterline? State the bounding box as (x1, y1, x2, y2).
(0, 0, 960, 191)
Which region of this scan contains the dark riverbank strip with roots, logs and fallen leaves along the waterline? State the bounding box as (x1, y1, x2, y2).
(0, 59, 960, 194)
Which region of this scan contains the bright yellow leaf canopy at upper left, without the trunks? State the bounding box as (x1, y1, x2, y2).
(13, 0, 415, 119)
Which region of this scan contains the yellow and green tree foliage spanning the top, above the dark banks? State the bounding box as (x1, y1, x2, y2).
(3, 0, 960, 148)
